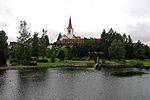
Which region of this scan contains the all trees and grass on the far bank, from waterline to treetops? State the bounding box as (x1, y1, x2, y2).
(0, 21, 150, 67)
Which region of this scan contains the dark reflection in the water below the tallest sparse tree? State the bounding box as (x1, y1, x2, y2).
(18, 69, 48, 100)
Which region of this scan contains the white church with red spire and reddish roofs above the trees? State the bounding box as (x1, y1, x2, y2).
(54, 17, 84, 46)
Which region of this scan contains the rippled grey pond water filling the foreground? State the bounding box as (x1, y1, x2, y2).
(0, 68, 150, 100)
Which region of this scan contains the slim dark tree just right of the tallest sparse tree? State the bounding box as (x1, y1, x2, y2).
(32, 32, 39, 58)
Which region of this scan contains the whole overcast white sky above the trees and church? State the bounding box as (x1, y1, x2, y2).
(0, 0, 150, 45)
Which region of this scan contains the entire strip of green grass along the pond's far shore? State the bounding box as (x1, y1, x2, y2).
(0, 59, 150, 69)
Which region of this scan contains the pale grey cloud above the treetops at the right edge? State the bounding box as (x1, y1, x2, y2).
(126, 22, 150, 45)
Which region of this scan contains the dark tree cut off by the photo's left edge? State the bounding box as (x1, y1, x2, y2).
(0, 30, 8, 65)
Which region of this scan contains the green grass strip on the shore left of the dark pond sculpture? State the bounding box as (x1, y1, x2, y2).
(0, 59, 94, 69)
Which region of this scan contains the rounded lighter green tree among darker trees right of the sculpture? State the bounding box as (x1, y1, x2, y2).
(108, 39, 125, 60)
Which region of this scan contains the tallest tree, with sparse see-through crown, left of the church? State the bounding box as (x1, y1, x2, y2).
(17, 21, 31, 64)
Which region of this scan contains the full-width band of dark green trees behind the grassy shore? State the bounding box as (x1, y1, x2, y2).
(0, 21, 150, 65)
